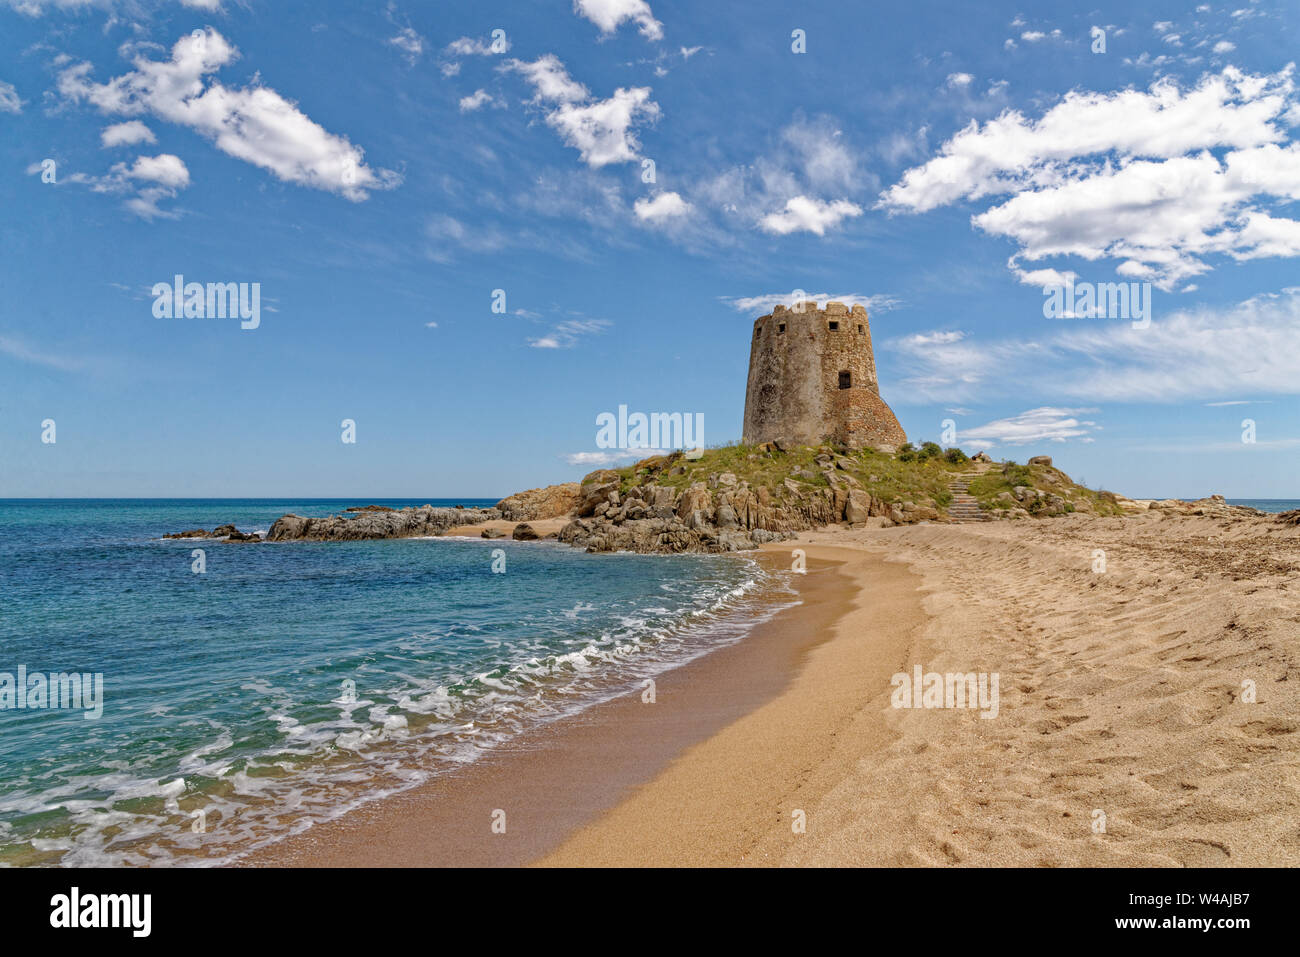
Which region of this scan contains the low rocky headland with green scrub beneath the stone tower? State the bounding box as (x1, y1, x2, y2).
(165, 442, 1268, 553)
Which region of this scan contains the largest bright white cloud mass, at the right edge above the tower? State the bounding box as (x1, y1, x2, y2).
(880, 66, 1300, 289)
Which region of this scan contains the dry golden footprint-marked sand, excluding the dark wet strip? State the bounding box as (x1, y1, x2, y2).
(542, 514, 1300, 866)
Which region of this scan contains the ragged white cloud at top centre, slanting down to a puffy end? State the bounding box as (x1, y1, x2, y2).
(502, 53, 659, 168)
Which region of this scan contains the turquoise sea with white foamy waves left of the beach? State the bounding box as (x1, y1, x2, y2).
(0, 499, 792, 863)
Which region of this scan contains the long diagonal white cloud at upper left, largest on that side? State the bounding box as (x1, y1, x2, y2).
(59, 27, 400, 202)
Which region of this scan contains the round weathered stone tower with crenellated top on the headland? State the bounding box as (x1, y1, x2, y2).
(744, 303, 907, 449)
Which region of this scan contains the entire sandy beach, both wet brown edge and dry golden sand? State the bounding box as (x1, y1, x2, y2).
(247, 512, 1300, 866)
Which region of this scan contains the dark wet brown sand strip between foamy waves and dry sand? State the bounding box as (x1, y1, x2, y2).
(244, 546, 883, 867)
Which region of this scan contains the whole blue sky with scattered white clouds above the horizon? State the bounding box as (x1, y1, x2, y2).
(0, 0, 1300, 498)
